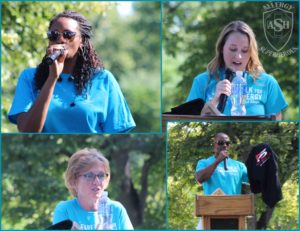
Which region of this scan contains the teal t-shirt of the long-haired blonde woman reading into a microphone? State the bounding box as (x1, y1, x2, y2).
(187, 70, 288, 116)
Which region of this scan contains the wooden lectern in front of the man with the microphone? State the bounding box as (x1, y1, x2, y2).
(195, 194, 254, 229)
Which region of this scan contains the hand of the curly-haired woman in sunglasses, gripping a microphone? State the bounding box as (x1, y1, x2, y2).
(47, 44, 68, 79)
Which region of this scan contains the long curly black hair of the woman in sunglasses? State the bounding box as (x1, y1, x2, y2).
(34, 11, 104, 94)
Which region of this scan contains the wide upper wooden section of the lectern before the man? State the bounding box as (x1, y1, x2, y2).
(195, 194, 255, 216)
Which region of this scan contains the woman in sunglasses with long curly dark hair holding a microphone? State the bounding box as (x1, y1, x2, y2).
(8, 11, 135, 133)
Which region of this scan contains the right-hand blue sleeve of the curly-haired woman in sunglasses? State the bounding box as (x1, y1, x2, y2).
(102, 72, 136, 133)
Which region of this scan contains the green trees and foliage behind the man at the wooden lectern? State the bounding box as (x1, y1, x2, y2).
(167, 122, 299, 230)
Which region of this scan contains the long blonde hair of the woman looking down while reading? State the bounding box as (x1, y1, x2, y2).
(207, 21, 264, 79)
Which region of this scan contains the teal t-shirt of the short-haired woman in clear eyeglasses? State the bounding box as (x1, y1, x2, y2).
(53, 198, 133, 230)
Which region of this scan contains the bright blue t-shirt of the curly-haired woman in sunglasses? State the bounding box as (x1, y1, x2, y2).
(8, 68, 135, 133)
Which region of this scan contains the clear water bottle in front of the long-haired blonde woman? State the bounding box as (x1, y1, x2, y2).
(230, 71, 247, 116)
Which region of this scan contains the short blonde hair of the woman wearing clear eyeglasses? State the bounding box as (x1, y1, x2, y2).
(65, 148, 110, 196)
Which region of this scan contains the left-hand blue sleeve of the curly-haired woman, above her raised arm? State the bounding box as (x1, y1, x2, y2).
(8, 68, 35, 124)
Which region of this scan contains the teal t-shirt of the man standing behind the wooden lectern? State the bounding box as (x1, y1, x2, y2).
(196, 156, 248, 195)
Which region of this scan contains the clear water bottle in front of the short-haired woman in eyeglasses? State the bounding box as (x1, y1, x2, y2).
(98, 191, 115, 230)
